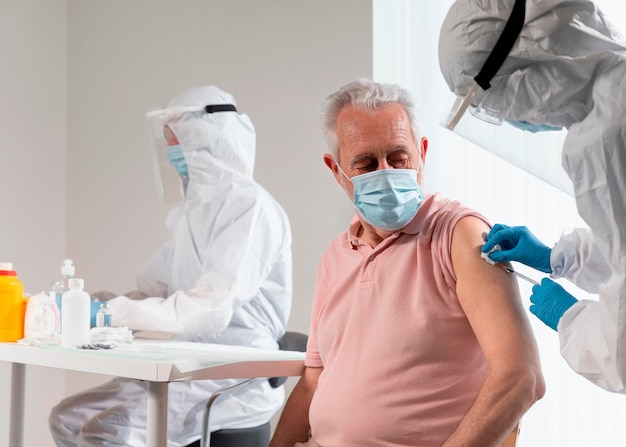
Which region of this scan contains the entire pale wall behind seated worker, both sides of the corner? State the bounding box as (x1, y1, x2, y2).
(0, 0, 372, 447)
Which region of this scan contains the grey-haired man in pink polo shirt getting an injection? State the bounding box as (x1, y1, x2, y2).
(270, 80, 544, 447)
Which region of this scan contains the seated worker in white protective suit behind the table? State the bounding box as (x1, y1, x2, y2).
(49, 86, 292, 447)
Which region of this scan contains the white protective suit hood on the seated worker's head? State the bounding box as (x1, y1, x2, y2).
(168, 86, 256, 184)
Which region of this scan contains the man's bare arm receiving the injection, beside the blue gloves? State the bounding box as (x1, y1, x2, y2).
(443, 217, 545, 447)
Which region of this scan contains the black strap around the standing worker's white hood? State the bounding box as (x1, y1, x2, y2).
(474, 0, 526, 90)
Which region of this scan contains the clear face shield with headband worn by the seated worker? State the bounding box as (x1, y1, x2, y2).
(146, 104, 237, 203)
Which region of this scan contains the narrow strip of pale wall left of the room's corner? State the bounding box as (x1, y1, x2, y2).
(0, 0, 67, 447)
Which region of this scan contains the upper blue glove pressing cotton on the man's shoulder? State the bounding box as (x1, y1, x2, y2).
(482, 224, 552, 273)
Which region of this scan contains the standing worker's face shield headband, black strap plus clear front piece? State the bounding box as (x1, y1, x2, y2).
(443, 0, 526, 130)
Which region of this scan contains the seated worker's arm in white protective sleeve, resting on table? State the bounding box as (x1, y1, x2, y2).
(109, 196, 291, 333)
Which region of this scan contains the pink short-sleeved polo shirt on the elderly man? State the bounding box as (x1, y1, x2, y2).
(306, 195, 487, 447)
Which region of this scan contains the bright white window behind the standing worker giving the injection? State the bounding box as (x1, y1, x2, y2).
(373, 0, 626, 447)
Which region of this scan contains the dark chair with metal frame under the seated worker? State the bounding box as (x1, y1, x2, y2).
(187, 332, 308, 447)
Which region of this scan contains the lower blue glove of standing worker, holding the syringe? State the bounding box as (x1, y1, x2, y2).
(530, 278, 578, 331)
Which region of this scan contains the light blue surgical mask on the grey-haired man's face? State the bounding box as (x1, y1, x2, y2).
(337, 165, 424, 231)
